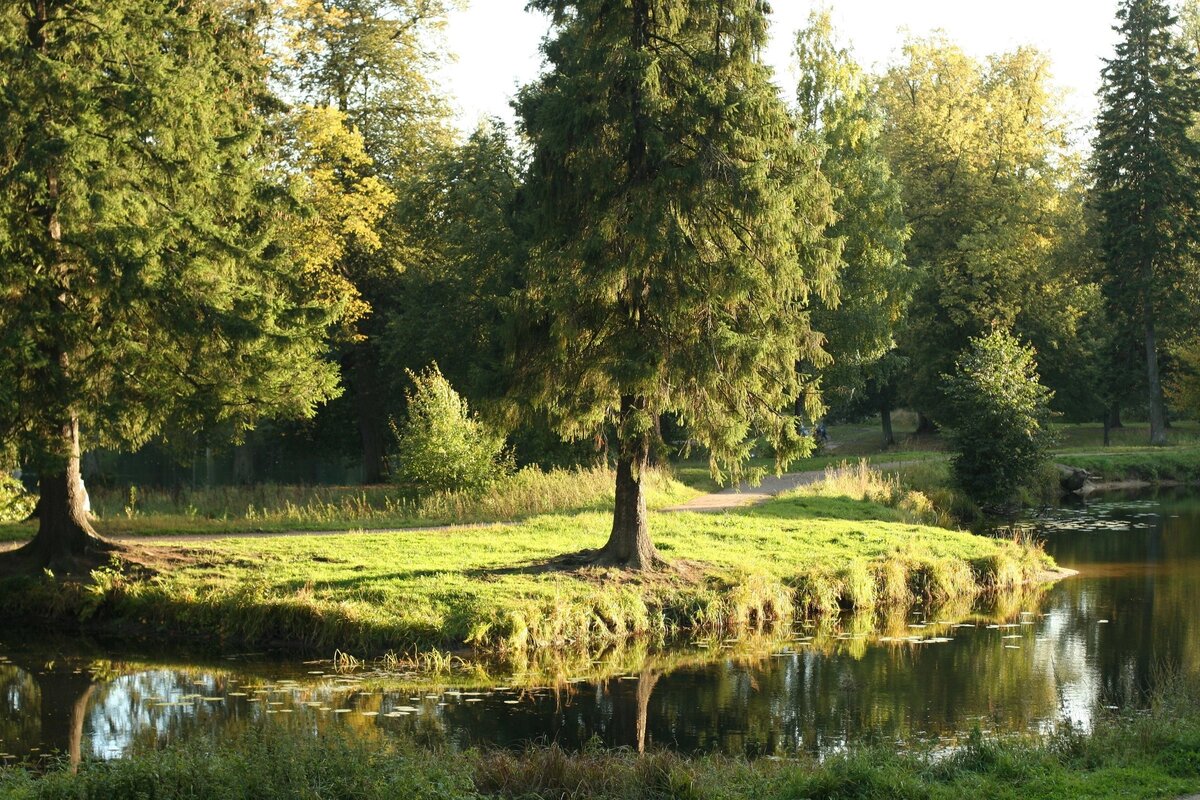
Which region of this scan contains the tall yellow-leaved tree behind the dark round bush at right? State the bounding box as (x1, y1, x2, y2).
(878, 37, 1086, 431)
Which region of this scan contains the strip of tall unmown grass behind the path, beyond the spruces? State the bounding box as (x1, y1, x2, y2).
(0, 468, 696, 541)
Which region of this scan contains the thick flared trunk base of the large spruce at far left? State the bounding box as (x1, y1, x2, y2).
(13, 420, 116, 573)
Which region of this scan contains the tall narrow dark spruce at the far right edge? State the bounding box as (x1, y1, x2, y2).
(1093, 0, 1200, 445)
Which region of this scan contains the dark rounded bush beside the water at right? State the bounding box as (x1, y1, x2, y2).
(942, 330, 1054, 509)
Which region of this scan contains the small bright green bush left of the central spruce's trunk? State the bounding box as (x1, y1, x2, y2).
(395, 363, 512, 494)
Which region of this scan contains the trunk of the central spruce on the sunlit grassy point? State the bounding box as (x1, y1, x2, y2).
(596, 396, 662, 570)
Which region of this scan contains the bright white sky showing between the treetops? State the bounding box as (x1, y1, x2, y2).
(442, 0, 1116, 143)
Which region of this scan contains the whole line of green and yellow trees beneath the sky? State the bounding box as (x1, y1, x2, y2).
(0, 0, 1200, 569)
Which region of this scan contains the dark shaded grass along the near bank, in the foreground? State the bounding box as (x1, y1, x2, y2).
(7, 688, 1200, 800)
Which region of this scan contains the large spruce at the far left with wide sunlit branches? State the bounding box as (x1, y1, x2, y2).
(0, 0, 347, 570)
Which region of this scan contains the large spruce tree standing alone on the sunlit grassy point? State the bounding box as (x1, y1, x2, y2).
(517, 0, 836, 569)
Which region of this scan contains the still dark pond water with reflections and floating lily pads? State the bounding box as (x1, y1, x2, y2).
(0, 494, 1200, 764)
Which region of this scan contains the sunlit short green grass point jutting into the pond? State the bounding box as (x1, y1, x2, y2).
(0, 482, 1050, 654)
